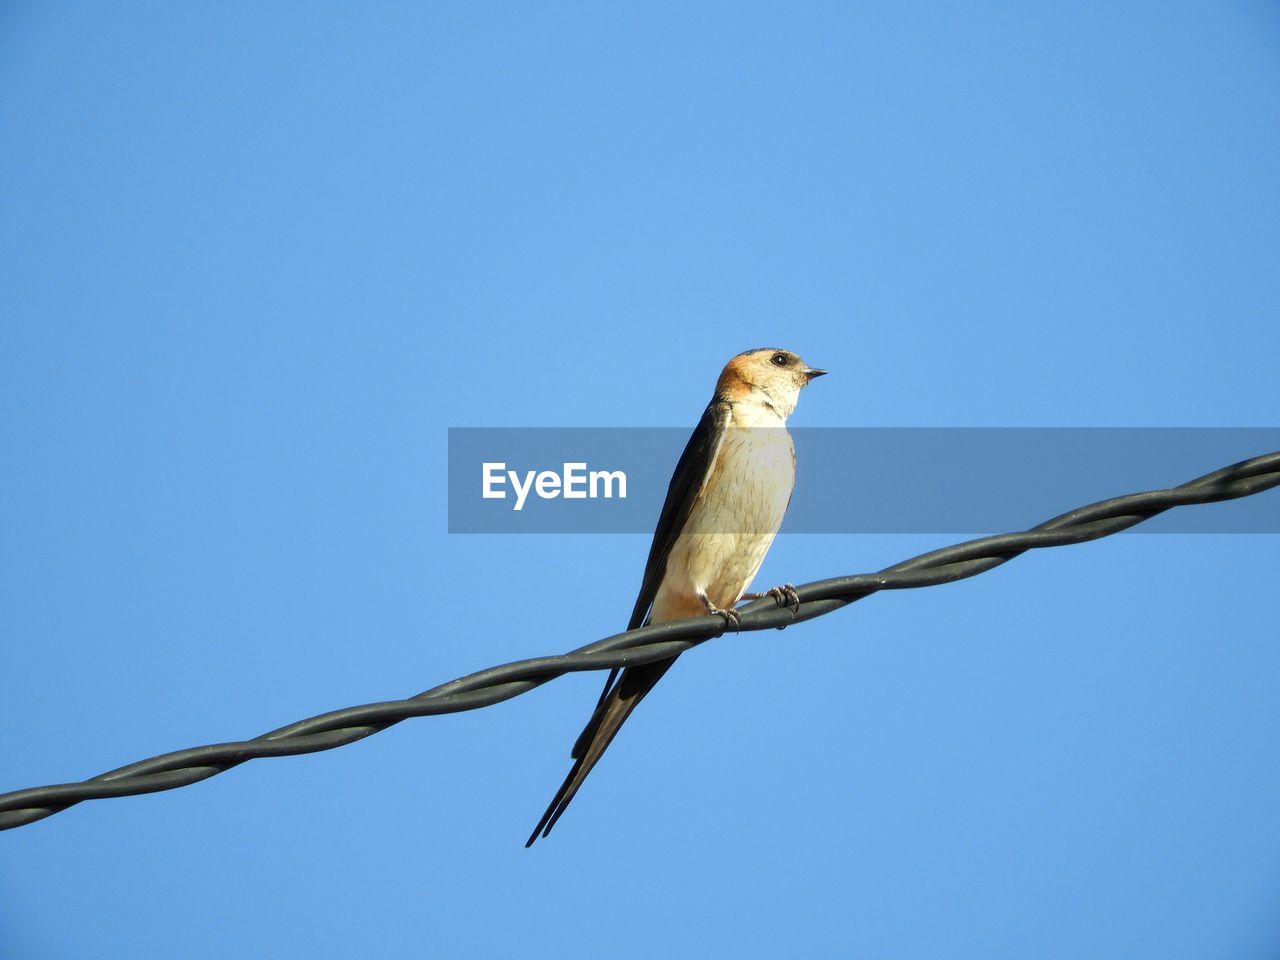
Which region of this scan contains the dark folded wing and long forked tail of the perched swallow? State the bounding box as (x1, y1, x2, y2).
(525, 399, 730, 846)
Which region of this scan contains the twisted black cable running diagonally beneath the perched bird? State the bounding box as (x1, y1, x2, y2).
(0, 452, 1280, 829)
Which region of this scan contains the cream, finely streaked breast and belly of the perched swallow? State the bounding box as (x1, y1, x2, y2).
(653, 403, 795, 621)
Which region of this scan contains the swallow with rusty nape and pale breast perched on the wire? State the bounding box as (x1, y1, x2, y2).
(525, 347, 827, 847)
